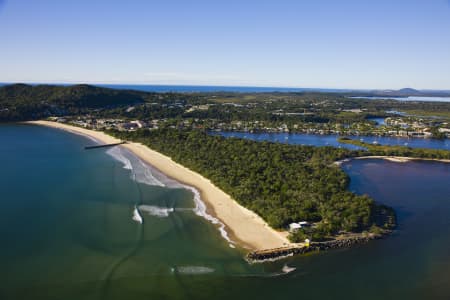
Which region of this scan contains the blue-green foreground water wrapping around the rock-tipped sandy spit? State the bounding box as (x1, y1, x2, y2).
(0, 125, 450, 299)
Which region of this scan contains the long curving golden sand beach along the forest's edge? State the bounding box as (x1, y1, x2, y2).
(24, 121, 296, 251)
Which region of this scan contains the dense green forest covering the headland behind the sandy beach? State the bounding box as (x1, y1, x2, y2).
(108, 129, 395, 241)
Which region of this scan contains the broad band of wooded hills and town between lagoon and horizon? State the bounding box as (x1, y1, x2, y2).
(0, 84, 450, 139)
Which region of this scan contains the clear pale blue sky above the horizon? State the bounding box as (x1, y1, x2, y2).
(0, 0, 450, 90)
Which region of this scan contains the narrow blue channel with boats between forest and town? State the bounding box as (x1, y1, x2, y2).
(212, 131, 450, 150)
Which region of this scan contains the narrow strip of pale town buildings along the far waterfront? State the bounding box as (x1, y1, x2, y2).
(49, 108, 450, 139)
